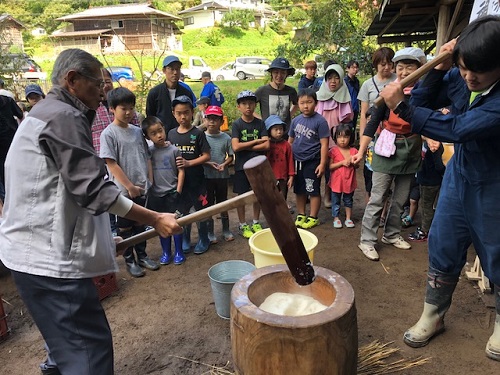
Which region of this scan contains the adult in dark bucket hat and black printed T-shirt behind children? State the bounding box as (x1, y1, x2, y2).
(255, 57, 298, 135)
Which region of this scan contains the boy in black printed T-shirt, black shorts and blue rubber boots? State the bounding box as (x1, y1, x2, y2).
(167, 95, 210, 254)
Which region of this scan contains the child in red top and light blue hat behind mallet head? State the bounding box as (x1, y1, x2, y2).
(265, 115, 295, 209)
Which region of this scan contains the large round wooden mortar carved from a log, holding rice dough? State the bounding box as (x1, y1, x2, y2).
(230, 265, 358, 375)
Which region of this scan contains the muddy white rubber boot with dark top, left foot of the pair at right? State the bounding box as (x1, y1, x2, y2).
(403, 268, 458, 348)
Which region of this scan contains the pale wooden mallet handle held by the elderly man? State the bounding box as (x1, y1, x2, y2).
(116, 191, 257, 255)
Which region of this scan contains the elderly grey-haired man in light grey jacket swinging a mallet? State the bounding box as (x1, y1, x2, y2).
(0, 49, 181, 375)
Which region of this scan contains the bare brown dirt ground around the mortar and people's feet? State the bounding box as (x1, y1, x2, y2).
(0, 176, 500, 375)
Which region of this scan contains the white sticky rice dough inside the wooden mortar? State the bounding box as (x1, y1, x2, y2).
(259, 293, 327, 316)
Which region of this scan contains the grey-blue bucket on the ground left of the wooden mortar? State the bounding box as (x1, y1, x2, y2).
(208, 260, 255, 319)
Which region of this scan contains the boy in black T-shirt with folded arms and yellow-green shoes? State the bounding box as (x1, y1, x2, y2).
(231, 90, 270, 238)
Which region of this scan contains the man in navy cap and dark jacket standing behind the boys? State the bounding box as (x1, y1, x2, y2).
(146, 55, 193, 134)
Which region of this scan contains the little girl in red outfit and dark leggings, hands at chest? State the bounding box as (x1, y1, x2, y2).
(329, 124, 358, 228)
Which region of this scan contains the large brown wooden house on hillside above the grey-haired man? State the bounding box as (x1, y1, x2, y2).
(51, 4, 182, 54)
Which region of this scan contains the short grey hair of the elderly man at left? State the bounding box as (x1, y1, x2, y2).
(51, 48, 103, 85)
